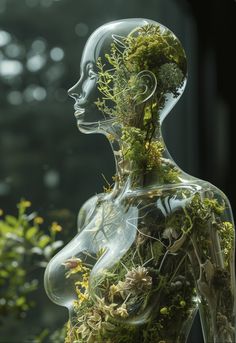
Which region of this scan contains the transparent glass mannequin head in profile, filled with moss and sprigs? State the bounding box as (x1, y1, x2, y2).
(68, 19, 187, 133)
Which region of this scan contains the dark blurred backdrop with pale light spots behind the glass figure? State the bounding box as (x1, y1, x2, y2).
(0, 0, 236, 343)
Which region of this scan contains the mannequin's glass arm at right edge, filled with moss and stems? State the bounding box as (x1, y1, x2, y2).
(189, 187, 235, 343)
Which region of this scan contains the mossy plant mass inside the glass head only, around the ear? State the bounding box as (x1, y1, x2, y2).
(97, 23, 187, 127)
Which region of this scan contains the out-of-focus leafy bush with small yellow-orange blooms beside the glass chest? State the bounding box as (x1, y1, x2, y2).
(0, 200, 63, 342)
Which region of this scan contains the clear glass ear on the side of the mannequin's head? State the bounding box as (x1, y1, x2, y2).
(134, 70, 157, 105)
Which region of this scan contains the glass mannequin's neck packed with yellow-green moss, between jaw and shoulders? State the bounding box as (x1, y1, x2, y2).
(102, 121, 180, 190)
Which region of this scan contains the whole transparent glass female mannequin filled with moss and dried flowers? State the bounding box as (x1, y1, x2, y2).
(45, 19, 235, 343)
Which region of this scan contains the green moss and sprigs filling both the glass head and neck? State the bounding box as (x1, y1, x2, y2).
(96, 24, 186, 183)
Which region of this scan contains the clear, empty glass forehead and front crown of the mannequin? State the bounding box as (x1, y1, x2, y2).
(81, 18, 154, 66)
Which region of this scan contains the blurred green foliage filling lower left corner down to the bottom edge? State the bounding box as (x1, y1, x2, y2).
(0, 200, 63, 343)
